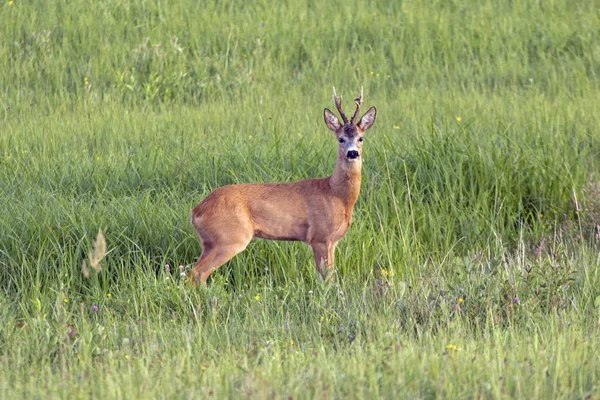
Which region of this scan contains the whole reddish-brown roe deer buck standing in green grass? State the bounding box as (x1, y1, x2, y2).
(191, 87, 377, 284)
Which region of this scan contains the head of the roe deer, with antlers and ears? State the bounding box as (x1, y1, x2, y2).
(324, 86, 377, 164)
